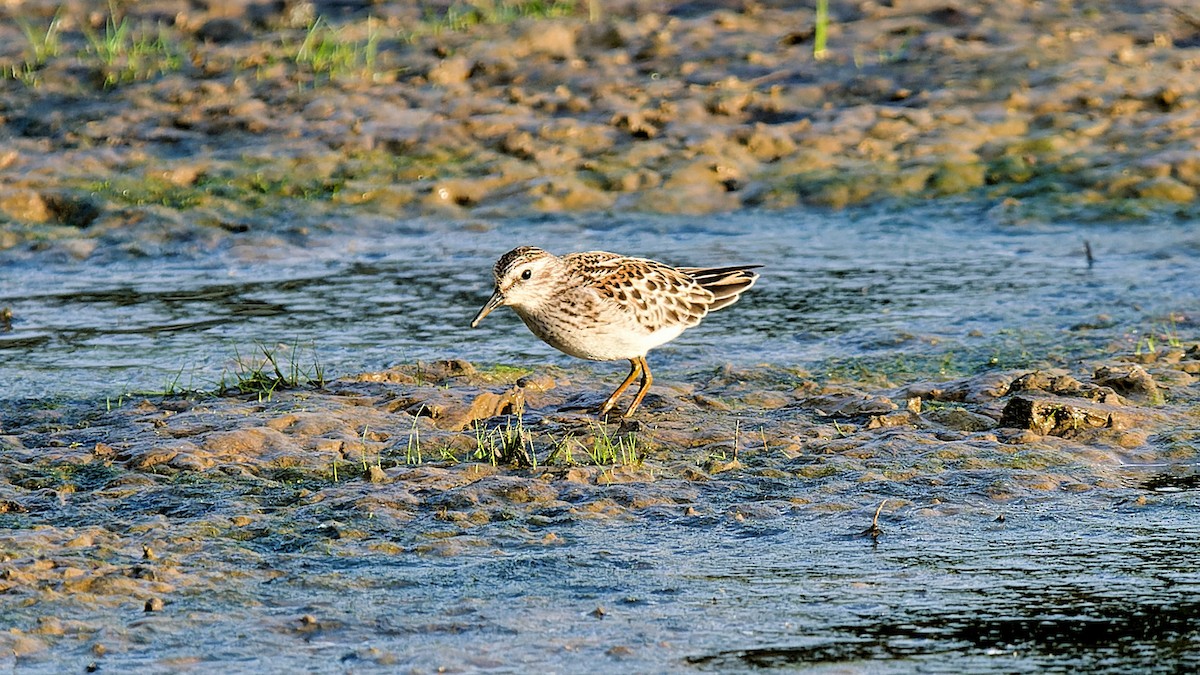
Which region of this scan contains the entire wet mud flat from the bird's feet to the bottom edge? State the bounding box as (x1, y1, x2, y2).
(0, 346, 1200, 671)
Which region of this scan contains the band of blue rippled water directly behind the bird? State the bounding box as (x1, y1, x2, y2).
(0, 204, 1200, 399)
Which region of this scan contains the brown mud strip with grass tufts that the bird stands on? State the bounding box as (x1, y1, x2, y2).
(0, 338, 1200, 667)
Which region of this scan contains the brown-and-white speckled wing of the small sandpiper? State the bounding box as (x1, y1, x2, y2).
(565, 251, 713, 333)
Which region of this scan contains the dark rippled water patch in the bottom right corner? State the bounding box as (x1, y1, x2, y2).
(685, 514, 1200, 671)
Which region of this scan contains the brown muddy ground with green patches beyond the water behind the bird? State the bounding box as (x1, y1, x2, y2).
(0, 0, 1200, 257)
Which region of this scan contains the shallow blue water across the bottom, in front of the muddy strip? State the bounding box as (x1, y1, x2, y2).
(0, 482, 1200, 673)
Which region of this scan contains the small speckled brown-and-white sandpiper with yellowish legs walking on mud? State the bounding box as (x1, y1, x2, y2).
(470, 246, 762, 417)
